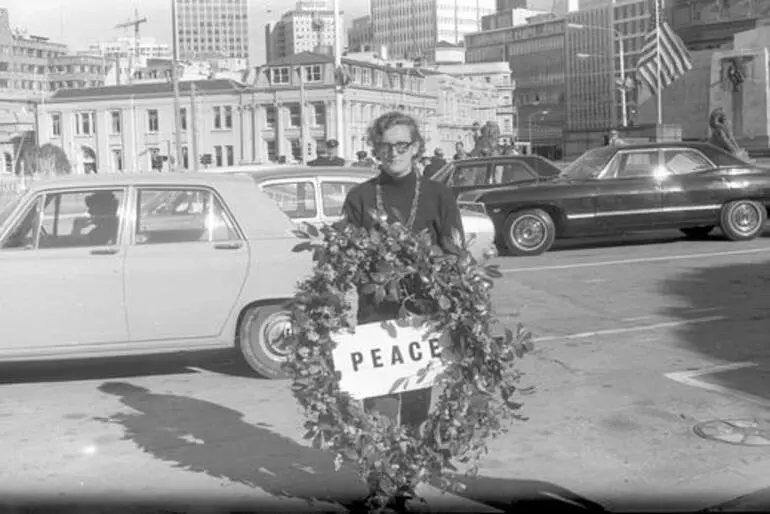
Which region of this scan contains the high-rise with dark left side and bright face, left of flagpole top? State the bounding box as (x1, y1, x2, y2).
(265, 5, 345, 62)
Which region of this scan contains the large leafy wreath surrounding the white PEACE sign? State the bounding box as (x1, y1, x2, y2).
(284, 211, 532, 512)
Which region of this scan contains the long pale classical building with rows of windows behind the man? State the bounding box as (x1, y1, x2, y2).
(31, 53, 498, 173)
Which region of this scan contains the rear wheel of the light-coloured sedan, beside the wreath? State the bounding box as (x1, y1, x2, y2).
(238, 305, 292, 379)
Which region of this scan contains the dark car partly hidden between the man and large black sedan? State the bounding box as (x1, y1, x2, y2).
(432, 155, 561, 196)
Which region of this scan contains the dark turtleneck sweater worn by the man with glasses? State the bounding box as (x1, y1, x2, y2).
(342, 171, 464, 244)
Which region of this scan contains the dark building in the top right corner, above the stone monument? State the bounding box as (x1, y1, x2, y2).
(666, 0, 770, 50)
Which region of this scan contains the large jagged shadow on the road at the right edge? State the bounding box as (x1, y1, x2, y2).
(661, 260, 770, 402)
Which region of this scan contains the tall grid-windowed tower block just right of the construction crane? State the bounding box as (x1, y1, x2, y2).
(173, 0, 249, 60)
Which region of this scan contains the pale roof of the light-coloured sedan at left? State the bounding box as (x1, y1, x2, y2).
(19, 172, 254, 192)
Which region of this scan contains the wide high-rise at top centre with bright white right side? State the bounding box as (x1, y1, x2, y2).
(370, 0, 497, 61)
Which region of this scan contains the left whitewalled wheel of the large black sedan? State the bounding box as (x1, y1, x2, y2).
(504, 209, 556, 255)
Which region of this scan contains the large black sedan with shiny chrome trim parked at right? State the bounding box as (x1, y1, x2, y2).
(458, 142, 770, 255)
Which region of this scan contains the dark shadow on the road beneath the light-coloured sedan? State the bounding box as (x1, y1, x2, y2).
(0, 349, 259, 385)
